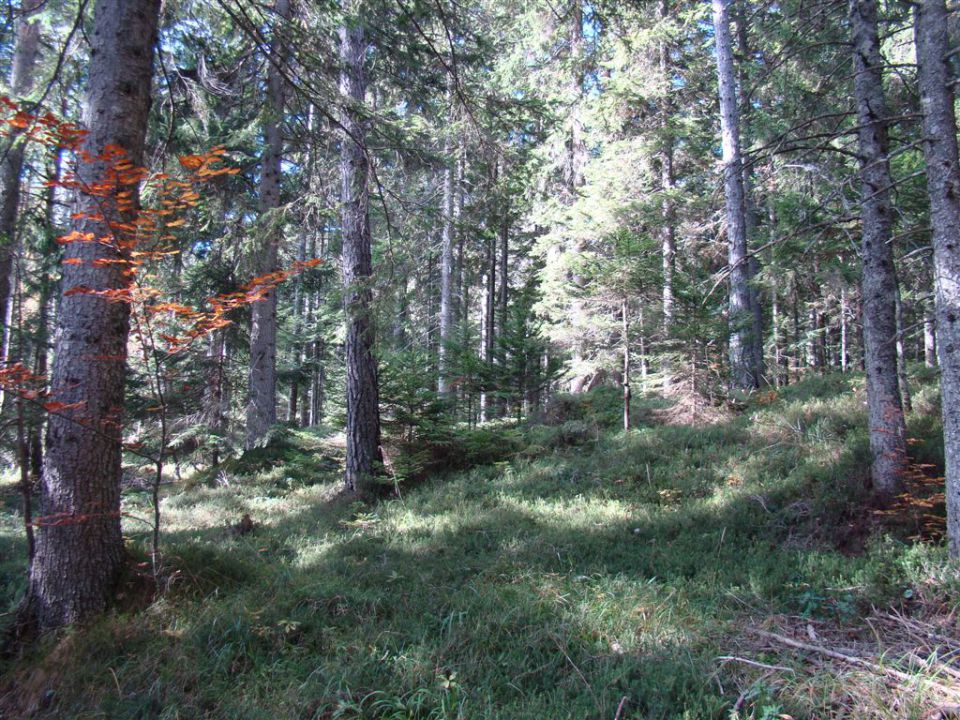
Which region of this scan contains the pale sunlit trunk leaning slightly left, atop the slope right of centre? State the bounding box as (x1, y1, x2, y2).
(713, 0, 760, 390)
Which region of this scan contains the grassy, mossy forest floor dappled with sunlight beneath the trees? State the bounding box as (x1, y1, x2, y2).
(0, 375, 960, 720)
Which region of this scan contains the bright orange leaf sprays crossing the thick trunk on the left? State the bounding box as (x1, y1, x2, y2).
(0, 96, 322, 388)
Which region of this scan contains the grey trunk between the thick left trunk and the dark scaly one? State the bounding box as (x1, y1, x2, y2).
(246, 0, 290, 449)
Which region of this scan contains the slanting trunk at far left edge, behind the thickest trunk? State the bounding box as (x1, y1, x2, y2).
(0, 0, 42, 368)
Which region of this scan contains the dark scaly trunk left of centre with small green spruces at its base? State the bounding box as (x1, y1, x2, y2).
(340, 11, 382, 495)
